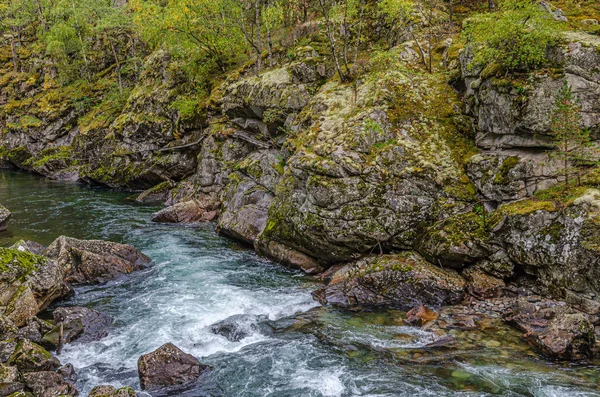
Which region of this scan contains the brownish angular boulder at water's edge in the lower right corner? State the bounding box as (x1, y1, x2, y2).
(504, 299, 596, 360)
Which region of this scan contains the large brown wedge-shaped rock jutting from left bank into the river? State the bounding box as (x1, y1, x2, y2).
(44, 236, 150, 284)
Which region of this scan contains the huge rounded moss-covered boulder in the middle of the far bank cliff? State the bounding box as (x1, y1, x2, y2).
(257, 58, 475, 265)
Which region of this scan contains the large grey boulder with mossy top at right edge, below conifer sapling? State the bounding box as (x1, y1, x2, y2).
(492, 195, 600, 306)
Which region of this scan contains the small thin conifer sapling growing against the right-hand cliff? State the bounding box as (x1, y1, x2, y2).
(551, 80, 597, 192)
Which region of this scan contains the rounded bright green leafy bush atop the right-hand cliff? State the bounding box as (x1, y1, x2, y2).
(464, 0, 560, 72)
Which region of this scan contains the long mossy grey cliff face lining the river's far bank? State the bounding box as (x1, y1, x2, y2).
(0, 24, 600, 314)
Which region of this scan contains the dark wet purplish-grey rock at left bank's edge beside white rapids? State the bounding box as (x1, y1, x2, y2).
(43, 307, 112, 349)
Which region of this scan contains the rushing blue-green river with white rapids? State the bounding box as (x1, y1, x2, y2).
(0, 170, 600, 397)
